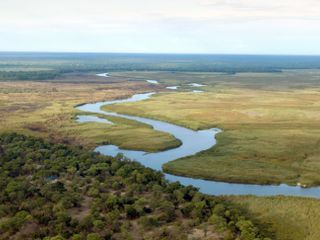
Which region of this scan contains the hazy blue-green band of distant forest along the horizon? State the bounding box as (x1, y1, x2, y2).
(0, 53, 320, 80)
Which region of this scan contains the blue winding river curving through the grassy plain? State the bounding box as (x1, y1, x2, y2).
(77, 93, 320, 198)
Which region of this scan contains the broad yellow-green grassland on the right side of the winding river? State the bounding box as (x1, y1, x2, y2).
(105, 70, 320, 186)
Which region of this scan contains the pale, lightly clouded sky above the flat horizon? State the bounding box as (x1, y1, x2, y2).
(0, 0, 320, 55)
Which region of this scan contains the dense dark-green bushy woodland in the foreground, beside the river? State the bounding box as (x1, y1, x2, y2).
(0, 133, 267, 240)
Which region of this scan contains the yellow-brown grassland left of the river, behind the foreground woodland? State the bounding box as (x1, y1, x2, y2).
(0, 79, 180, 152)
